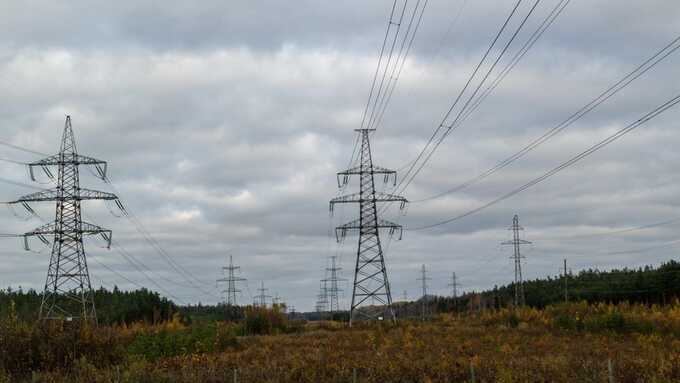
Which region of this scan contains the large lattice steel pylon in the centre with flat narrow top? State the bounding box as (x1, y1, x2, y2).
(330, 129, 408, 327)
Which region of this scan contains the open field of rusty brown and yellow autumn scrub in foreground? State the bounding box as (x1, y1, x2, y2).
(0, 303, 680, 382)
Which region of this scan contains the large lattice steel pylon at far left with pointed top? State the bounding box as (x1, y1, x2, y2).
(10, 116, 118, 323)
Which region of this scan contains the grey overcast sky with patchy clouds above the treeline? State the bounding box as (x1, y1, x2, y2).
(0, 0, 680, 310)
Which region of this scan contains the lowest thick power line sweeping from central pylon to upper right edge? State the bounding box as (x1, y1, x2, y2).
(408, 95, 680, 230)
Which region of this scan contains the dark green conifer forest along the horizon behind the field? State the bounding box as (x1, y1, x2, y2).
(0, 261, 680, 324)
